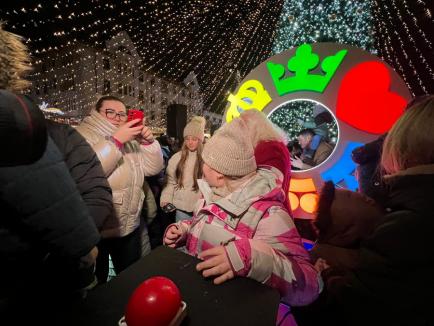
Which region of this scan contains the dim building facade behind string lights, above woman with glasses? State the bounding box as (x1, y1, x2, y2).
(30, 32, 203, 129)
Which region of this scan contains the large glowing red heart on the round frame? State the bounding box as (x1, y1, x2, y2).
(336, 61, 407, 134)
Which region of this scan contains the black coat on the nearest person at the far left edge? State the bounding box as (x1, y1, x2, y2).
(0, 138, 99, 303)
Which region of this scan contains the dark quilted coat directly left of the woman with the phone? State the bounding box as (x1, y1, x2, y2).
(47, 121, 113, 230)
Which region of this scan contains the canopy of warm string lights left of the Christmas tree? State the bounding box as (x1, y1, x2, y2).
(0, 0, 283, 119)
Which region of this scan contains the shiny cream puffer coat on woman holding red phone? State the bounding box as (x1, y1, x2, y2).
(77, 111, 163, 238)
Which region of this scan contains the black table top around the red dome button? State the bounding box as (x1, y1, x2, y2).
(62, 246, 279, 326)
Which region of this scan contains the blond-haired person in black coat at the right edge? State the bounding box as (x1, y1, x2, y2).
(299, 96, 434, 325)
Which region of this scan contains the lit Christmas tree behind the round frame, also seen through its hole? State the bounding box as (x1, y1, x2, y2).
(270, 0, 375, 142)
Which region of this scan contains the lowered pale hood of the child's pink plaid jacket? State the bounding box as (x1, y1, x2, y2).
(198, 166, 285, 216)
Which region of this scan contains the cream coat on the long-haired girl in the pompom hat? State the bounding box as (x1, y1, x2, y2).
(160, 151, 200, 212)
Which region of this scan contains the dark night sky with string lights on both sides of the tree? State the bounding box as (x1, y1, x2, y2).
(0, 0, 434, 113)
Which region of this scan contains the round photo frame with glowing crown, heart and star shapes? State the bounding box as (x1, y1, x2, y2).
(224, 43, 411, 219)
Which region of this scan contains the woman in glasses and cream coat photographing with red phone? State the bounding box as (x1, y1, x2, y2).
(77, 96, 163, 283)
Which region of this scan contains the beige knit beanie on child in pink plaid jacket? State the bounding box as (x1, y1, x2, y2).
(202, 119, 256, 177)
